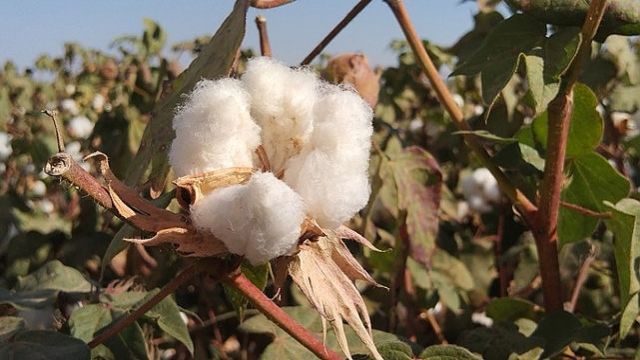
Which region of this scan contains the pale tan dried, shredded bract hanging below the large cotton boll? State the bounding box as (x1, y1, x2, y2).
(285, 230, 382, 360)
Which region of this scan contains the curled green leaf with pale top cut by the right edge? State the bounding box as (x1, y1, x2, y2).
(606, 199, 640, 332)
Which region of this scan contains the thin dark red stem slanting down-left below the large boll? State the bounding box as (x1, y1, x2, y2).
(88, 263, 202, 349)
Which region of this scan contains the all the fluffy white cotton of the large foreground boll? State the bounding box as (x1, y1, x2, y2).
(169, 58, 373, 264)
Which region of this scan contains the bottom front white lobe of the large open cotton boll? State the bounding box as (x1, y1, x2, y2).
(191, 172, 305, 265)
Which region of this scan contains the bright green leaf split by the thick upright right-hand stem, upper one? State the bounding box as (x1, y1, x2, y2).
(532, 84, 604, 159)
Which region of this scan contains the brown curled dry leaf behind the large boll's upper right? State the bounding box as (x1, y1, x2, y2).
(325, 53, 380, 108)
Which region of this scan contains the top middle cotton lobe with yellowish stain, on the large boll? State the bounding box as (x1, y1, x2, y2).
(242, 57, 320, 174)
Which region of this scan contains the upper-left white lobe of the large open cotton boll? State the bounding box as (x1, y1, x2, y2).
(169, 79, 260, 176)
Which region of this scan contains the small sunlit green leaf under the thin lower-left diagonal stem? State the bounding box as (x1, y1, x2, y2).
(143, 290, 193, 355)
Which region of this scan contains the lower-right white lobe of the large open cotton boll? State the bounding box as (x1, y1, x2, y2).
(284, 150, 371, 229)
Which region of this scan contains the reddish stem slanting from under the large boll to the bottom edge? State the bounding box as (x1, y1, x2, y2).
(221, 273, 342, 360)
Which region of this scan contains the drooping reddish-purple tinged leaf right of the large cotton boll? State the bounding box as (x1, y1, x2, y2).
(387, 146, 442, 266)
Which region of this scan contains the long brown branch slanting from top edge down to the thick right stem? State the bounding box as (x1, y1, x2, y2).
(385, 0, 537, 225)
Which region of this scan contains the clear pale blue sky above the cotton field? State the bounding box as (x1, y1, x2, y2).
(0, 0, 498, 67)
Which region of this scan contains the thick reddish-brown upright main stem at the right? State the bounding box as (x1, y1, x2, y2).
(532, 0, 607, 312)
